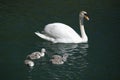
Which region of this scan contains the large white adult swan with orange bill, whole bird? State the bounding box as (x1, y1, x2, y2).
(35, 11, 89, 43)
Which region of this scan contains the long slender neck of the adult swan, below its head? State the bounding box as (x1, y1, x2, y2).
(79, 16, 88, 42)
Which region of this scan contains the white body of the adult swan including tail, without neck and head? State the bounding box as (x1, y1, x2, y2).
(35, 23, 80, 43)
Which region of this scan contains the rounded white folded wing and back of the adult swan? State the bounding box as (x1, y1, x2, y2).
(44, 23, 80, 42)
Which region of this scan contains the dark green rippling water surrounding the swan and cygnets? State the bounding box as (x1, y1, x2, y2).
(0, 0, 120, 80)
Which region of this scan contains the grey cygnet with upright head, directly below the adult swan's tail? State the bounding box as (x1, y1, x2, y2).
(27, 48, 46, 60)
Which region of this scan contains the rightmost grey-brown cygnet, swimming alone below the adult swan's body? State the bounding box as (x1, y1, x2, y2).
(50, 53, 68, 64)
